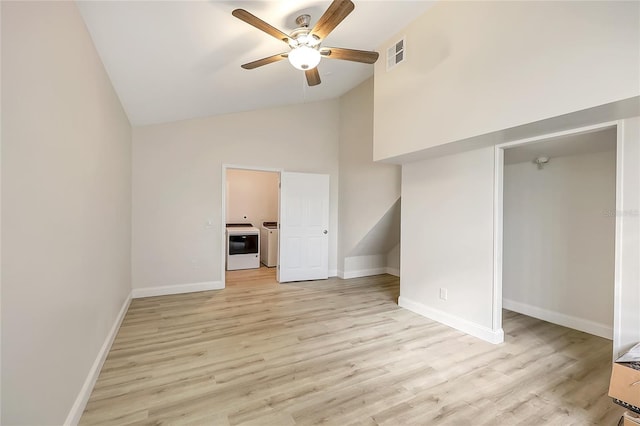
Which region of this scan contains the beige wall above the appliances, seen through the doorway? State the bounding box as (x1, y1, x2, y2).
(225, 169, 280, 228)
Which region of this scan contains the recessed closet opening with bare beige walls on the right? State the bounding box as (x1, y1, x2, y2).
(498, 125, 617, 353)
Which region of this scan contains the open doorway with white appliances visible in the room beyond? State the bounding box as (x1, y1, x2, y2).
(223, 166, 280, 286)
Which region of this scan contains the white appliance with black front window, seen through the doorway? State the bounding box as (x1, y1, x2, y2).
(226, 223, 260, 271)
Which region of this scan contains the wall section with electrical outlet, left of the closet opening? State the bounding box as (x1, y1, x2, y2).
(399, 147, 500, 341)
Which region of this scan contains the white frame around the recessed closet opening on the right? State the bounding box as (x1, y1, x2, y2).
(492, 121, 623, 358)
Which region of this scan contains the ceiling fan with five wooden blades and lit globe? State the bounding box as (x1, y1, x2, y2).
(232, 0, 378, 86)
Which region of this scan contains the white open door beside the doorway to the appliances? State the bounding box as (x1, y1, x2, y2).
(278, 172, 329, 282)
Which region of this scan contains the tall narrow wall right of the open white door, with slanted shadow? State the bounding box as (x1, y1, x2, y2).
(338, 79, 400, 275)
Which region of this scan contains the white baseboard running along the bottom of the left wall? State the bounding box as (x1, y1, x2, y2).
(64, 293, 131, 426)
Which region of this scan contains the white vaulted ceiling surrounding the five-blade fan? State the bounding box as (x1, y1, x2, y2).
(78, 0, 433, 126)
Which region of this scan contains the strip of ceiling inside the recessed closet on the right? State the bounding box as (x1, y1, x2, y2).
(504, 127, 617, 164)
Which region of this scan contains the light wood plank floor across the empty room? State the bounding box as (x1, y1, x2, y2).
(81, 268, 623, 426)
